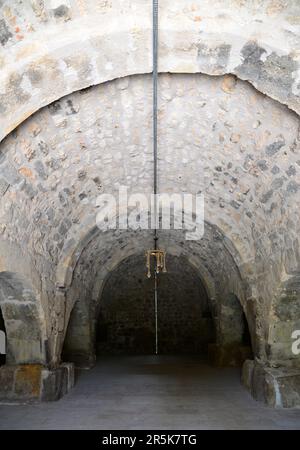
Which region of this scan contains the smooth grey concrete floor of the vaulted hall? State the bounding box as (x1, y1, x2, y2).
(0, 356, 300, 430)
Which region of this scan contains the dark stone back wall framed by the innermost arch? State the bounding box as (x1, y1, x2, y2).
(96, 255, 216, 357)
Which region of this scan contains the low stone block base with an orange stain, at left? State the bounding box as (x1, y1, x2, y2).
(0, 363, 74, 401)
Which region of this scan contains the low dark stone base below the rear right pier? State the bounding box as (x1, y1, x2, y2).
(208, 344, 252, 367)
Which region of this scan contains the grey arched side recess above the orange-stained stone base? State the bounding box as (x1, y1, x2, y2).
(0, 272, 47, 365)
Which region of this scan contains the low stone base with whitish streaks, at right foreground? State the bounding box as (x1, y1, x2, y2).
(242, 360, 300, 408)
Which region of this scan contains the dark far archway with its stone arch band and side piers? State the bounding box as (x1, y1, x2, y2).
(62, 229, 256, 367)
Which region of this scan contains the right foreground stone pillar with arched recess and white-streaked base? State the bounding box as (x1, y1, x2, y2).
(242, 273, 300, 408)
